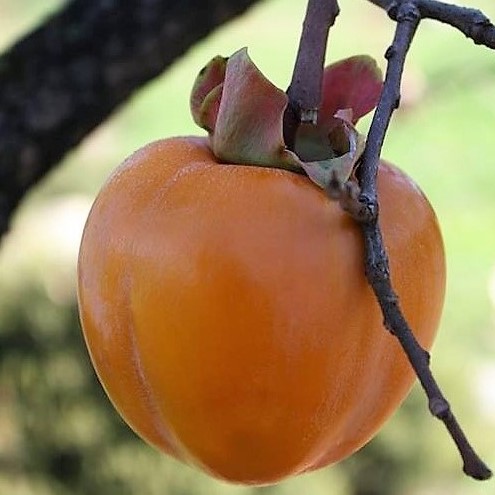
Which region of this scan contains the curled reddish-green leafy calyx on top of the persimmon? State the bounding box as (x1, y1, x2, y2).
(190, 48, 382, 190)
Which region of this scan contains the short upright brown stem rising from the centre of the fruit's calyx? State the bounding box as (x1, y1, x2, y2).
(284, 0, 340, 151)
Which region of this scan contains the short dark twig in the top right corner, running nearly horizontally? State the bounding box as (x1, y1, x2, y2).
(369, 0, 495, 48)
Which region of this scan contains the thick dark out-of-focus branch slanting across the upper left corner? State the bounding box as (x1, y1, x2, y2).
(0, 0, 264, 241)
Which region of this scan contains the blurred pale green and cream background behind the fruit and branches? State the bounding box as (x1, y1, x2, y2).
(0, 0, 495, 495)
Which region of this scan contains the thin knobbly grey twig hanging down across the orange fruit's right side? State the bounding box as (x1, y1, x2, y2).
(359, 0, 492, 480)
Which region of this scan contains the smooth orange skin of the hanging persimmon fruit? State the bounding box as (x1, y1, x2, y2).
(78, 137, 445, 484)
